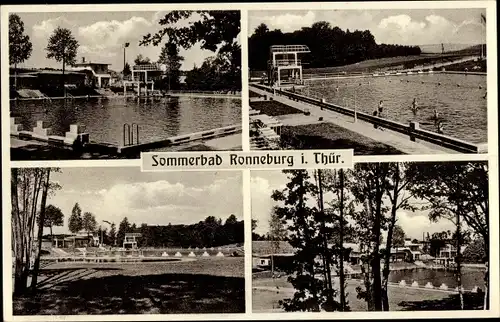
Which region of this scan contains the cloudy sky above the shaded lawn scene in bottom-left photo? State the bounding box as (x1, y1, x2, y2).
(45, 167, 243, 233)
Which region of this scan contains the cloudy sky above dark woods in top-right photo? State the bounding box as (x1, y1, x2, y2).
(248, 8, 486, 45)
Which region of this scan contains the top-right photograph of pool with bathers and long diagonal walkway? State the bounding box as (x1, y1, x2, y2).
(247, 8, 488, 155)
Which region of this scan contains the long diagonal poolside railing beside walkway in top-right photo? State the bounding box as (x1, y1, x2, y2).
(252, 84, 481, 153)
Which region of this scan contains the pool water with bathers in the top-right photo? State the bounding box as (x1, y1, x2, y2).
(299, 73, 488, 143)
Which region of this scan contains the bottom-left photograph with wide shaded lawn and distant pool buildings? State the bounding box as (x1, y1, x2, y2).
(10, 167, 245, 316)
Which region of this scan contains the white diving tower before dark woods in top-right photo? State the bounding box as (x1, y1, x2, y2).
(268, 45, 311, 87)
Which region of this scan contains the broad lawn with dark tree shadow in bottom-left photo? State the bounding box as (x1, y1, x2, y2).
(13, 257, 245, 315)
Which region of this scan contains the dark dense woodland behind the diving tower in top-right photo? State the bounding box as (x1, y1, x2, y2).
(248, 21, 421, 70)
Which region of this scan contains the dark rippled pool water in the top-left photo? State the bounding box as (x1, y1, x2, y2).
(10, 97, 241, 145)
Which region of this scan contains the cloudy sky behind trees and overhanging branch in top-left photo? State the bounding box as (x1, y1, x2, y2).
(13, 11, 240, 71)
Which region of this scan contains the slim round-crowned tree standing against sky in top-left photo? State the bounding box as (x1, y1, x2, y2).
(45, 27, 79, 96)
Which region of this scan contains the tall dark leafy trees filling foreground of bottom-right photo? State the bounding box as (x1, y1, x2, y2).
(268, 162, 489, 311)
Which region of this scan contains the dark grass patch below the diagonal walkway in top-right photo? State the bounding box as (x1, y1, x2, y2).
(281, 123, 402, 155)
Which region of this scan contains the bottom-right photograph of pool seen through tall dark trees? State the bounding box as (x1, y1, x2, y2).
(251, 161, 488, 313)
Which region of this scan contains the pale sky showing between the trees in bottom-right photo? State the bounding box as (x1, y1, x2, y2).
(254, 171, 455, 240)
